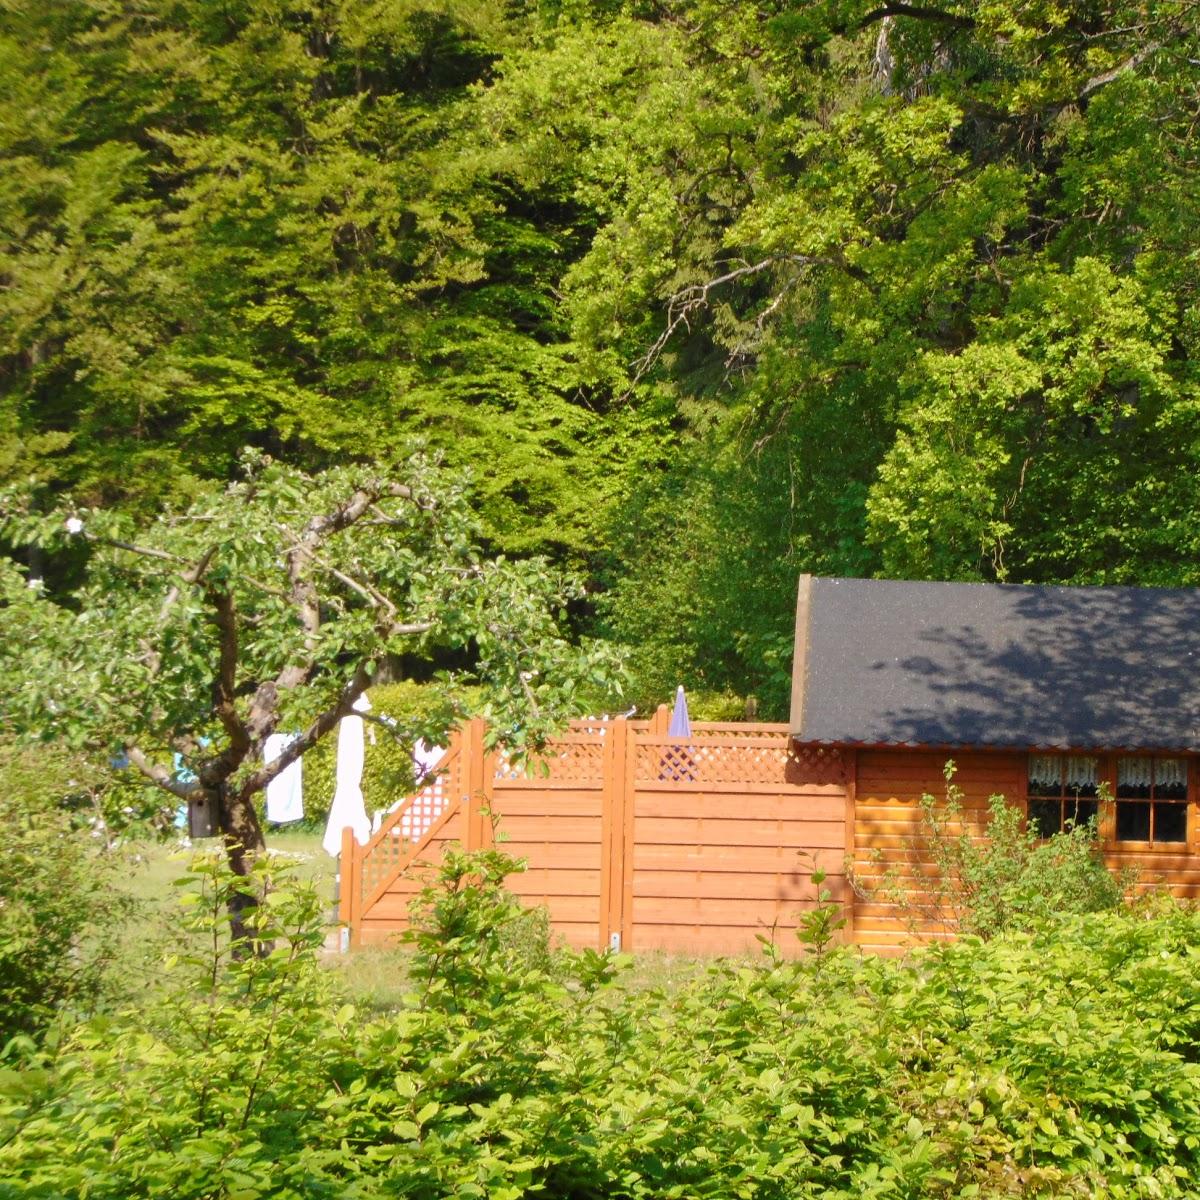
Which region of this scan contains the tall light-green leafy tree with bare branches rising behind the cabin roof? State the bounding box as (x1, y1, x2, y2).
(470, 0, 1200, 686)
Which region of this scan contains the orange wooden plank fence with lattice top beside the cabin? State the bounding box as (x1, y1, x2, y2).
(341, 708, 854, 954)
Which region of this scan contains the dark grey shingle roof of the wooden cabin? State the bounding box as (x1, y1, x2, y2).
(792, 576, 1200, 751)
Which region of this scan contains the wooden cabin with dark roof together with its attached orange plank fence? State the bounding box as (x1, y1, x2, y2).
(341, 576, 1200, 954)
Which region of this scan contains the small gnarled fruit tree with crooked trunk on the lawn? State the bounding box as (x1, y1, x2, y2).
(0, 454, 617, 916)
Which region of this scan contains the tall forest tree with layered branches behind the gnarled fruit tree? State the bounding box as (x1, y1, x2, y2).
(0, 0, 619, 559)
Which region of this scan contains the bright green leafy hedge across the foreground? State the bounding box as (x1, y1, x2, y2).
(0, 852, 1200, 1200)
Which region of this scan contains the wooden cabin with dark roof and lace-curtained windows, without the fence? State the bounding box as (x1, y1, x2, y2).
(790, 576, 1200, 952)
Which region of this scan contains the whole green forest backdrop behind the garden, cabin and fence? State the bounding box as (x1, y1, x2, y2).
(0, 0, 1200, 714)
